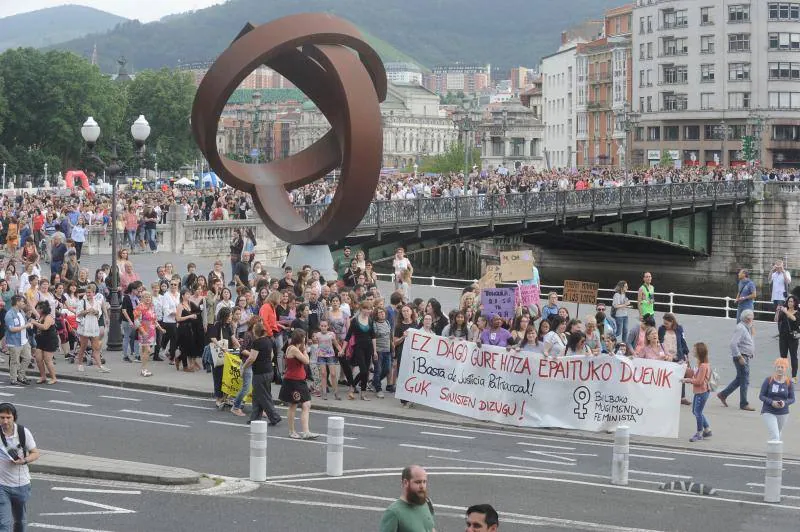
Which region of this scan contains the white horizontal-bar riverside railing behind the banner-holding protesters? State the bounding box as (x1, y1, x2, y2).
(377, 273, 775, 320)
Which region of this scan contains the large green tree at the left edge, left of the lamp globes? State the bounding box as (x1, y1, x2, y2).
(0, 48, 124, 169)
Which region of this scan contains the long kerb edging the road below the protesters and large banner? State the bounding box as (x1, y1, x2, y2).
(6, 369, 800, 460)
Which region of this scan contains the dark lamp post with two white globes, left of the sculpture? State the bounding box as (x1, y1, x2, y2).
(81, 115, 150, 351)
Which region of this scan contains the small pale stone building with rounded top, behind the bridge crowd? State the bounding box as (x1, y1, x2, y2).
(477, 99, 545, 171)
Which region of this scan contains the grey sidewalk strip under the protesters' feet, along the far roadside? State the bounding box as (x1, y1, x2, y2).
(14, 353, 800, 460)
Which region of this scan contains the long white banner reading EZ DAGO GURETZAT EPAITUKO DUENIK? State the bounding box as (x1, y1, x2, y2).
(395, 330, 684, 438)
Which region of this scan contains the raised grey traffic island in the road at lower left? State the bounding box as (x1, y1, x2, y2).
(28, 449, 201, 486)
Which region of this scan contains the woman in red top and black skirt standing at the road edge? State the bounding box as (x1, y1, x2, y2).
(278, 329, 320, 440)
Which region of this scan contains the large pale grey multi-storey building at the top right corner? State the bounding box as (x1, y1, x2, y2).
(632, 0, 800, 167)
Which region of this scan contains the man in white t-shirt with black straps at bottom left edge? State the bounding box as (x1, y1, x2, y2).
(0, 403, 39, 532)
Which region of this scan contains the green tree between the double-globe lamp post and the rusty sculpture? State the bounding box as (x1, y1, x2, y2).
(126, 68, 197, 170)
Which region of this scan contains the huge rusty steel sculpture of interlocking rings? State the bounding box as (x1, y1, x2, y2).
(192, 14, 387, 244)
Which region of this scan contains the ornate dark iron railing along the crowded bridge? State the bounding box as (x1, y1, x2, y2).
(297, 180, 756, 230)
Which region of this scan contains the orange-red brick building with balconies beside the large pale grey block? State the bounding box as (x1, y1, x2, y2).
(575, 4, 633, 167)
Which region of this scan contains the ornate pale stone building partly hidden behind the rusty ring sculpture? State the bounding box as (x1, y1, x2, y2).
(289, 83, 458, 168)
